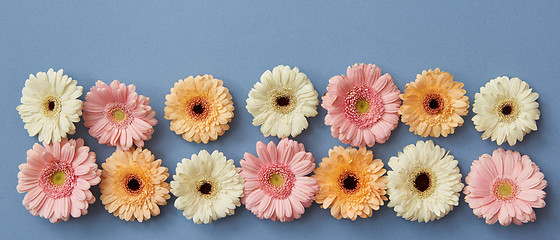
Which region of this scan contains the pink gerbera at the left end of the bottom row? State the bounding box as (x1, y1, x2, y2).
(17, 138, 101, 223)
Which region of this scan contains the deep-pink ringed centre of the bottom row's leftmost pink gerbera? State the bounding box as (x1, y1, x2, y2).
(39, 161, 77, 198)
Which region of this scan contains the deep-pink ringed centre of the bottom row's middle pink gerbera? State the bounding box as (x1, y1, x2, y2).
(258, 164, 296, 199)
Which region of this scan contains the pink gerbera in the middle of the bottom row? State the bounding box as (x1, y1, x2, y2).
(241, 138, 319, 222)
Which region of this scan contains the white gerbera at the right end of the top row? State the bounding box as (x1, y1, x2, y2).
(472, 76, 540, 146)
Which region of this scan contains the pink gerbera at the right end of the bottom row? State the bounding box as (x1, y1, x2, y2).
(463, 148, 547, 226)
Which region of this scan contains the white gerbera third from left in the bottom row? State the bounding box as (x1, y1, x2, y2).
(171, 150, 243, 224)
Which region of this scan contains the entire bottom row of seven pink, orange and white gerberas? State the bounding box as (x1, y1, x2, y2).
(17, 139, 547, 225)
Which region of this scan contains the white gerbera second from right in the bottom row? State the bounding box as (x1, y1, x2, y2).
(387, 140, 463, 222)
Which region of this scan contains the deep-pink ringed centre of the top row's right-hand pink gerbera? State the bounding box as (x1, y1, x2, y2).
(343, 86, 384, 128)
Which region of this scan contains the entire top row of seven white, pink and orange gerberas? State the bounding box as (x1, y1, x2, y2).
(17, 64, 540, 150)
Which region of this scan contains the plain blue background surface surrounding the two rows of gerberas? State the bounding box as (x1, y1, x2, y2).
(0, 1, 560, 239)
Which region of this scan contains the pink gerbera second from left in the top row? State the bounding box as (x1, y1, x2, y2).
(84, 80, 157, 150)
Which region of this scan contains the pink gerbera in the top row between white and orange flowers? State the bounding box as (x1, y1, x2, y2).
(321, 63, 401, 147)
